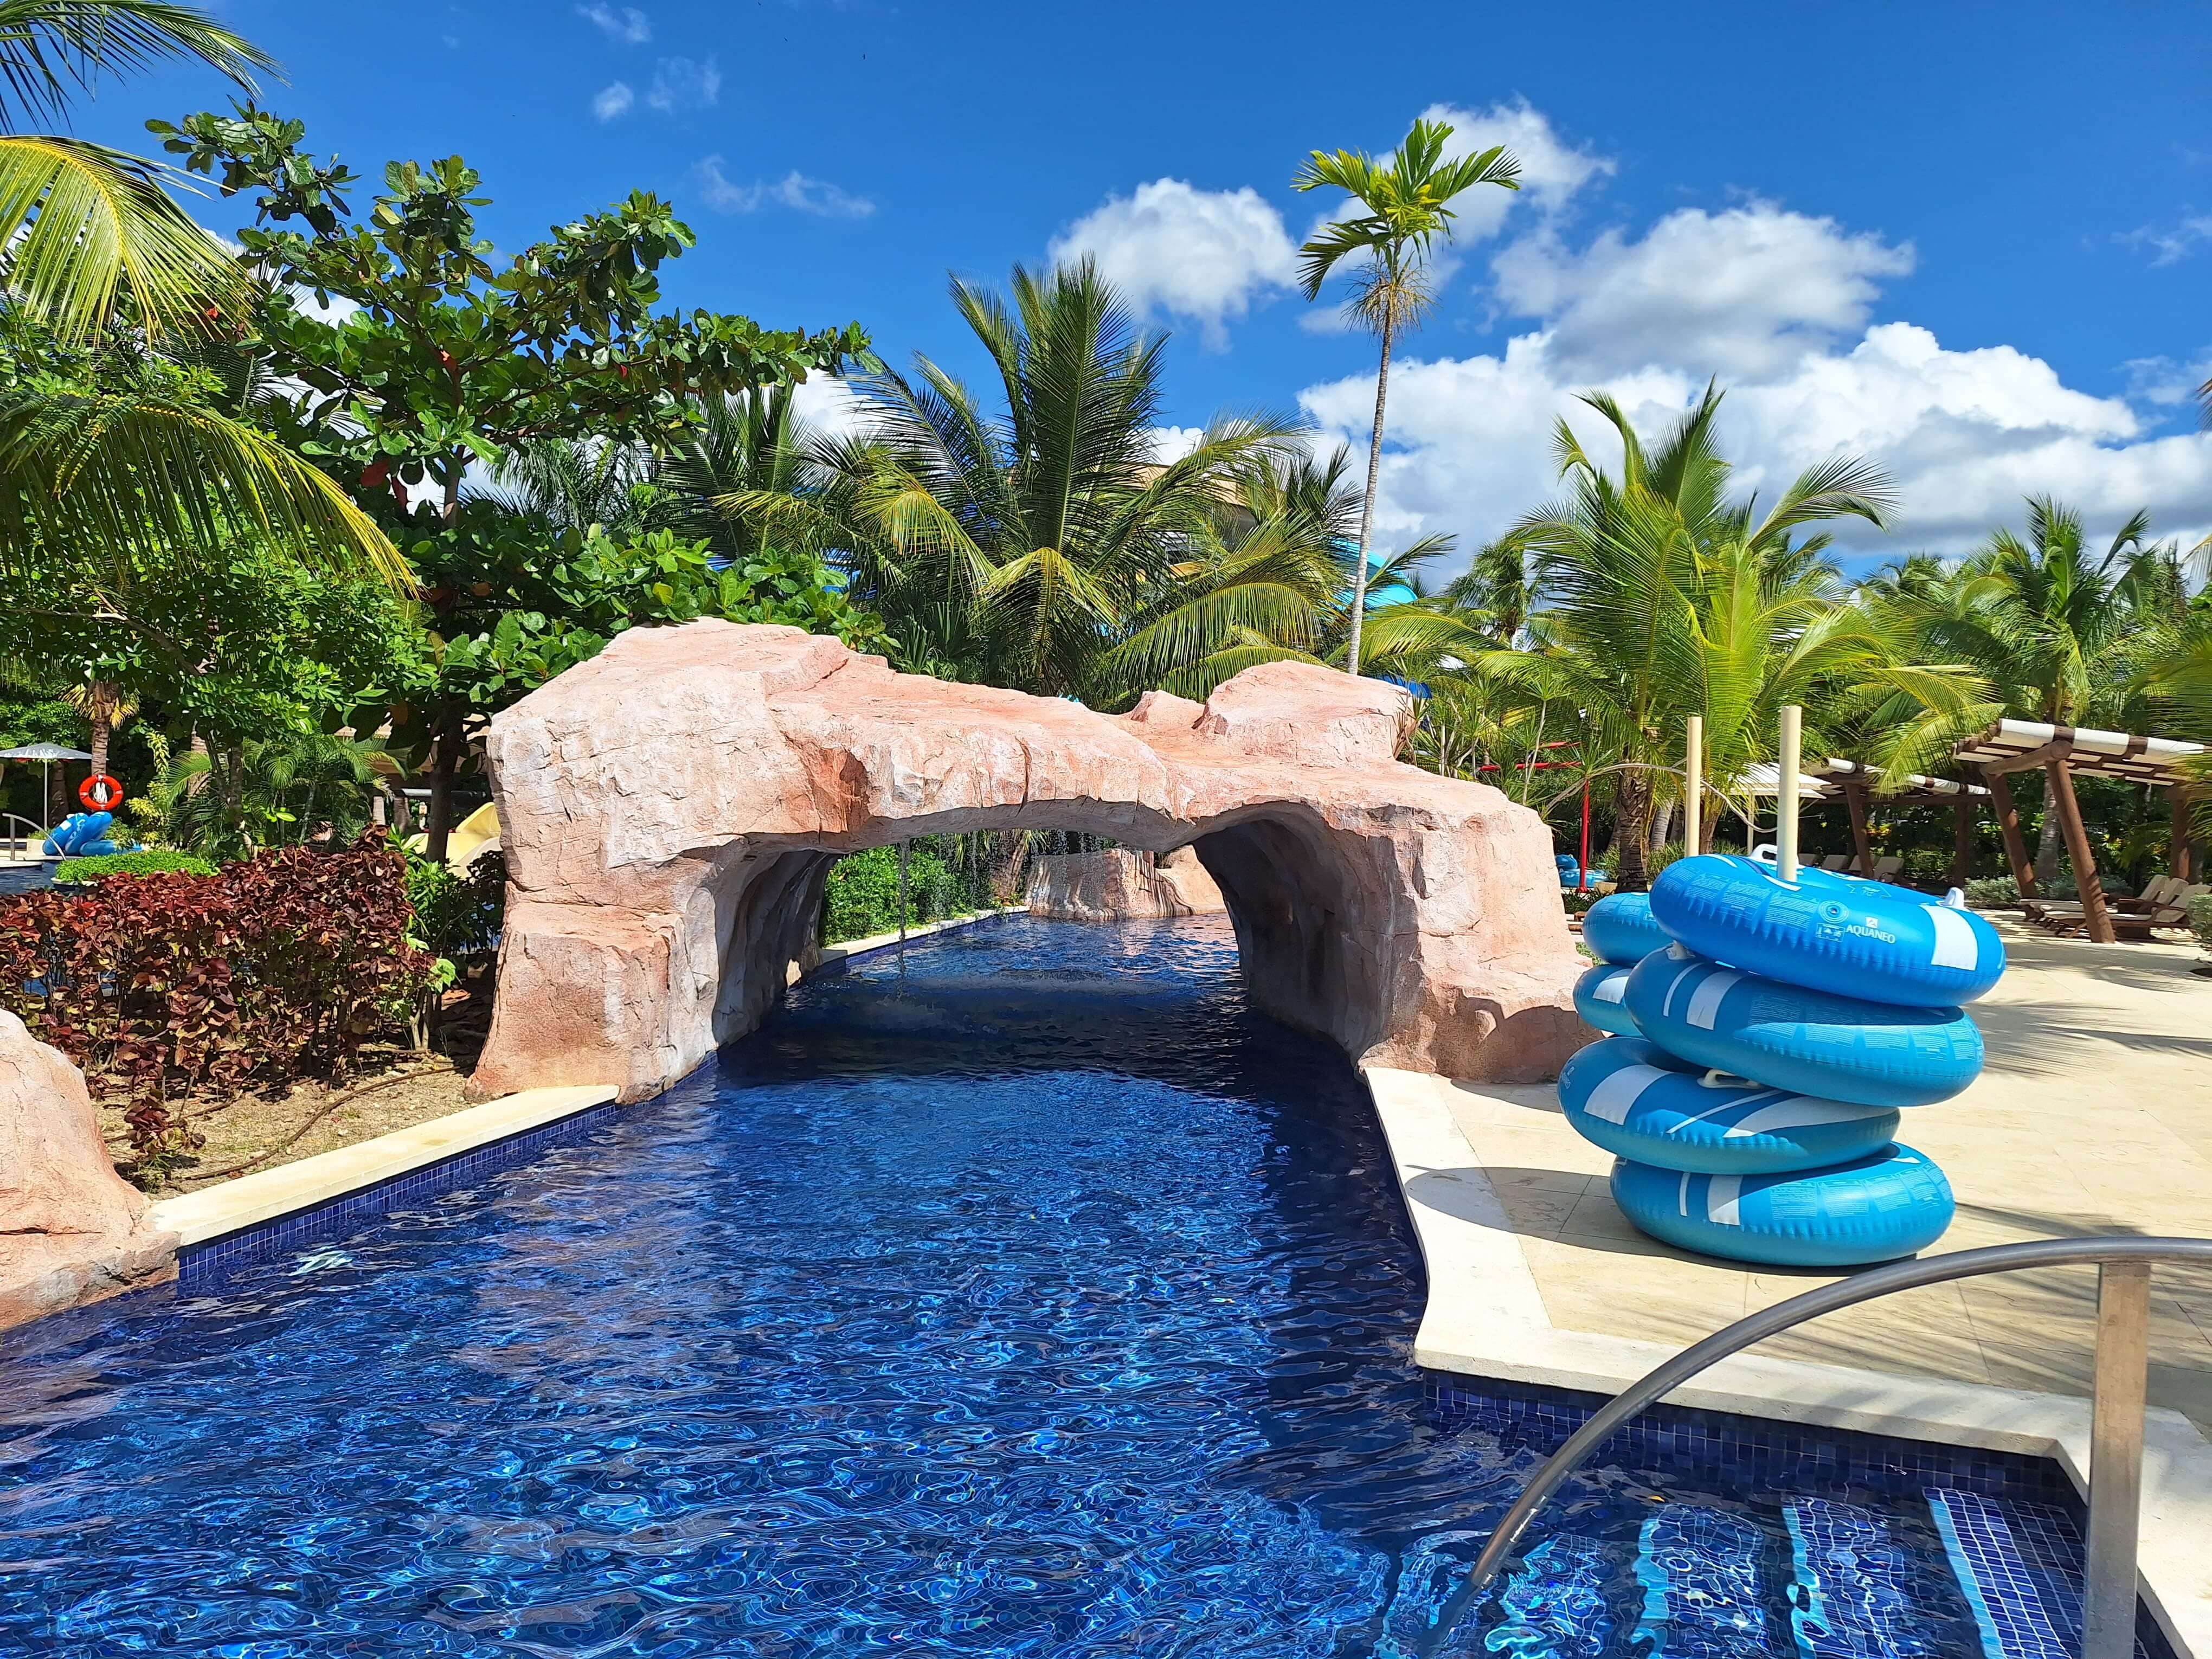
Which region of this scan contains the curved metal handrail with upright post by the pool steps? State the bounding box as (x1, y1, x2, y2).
(1431, 1237, 2212, 1659)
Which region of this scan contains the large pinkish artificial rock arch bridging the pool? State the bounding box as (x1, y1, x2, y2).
(471, 621, 1588, 1099)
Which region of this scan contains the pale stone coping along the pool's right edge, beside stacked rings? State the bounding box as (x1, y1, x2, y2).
(1360, 1066, 2212, 1659)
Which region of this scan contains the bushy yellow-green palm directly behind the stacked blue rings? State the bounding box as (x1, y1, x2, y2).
(1469, 387, 1984, 891)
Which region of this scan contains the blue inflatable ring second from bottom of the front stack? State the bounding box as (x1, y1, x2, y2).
(1559, 1038, 1898, 1174)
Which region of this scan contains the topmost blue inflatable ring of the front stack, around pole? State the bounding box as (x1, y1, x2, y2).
(1663, 854, 2004, 1008)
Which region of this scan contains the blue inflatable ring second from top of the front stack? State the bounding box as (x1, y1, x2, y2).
(1624, 947, 1982, 1106)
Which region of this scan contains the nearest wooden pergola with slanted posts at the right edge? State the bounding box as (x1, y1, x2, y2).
(1951, 721, 2205, 944)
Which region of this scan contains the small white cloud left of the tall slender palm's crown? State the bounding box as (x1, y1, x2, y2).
(1051, 179, 1298, 350)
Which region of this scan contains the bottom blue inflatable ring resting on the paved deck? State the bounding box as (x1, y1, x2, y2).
(1612, 1146, 1956, 1268)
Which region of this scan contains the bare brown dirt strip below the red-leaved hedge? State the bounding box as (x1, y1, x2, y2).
(100, 973, 491, 1197)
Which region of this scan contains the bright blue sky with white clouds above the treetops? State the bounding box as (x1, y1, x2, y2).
(78, 0, 2212, 570)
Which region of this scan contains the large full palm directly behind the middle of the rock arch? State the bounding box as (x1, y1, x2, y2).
(719, 259, 1298, 695)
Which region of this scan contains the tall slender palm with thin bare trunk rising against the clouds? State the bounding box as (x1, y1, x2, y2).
(1292, 121, 1520, 674)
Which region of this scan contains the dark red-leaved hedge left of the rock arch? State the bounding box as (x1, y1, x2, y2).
(0, 829, 436, 1163)
